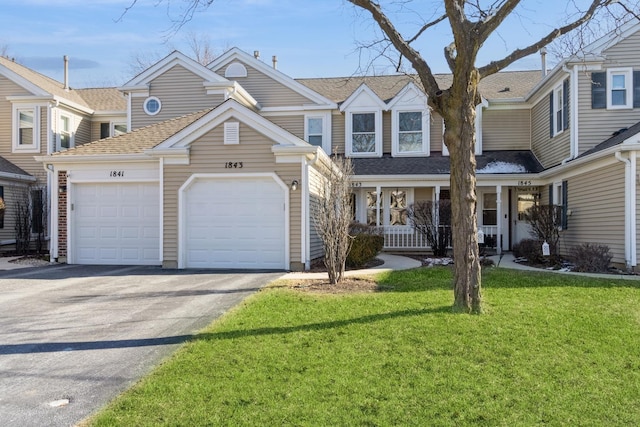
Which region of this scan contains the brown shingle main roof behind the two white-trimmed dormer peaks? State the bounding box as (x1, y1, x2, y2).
(296, 70, 542, 103)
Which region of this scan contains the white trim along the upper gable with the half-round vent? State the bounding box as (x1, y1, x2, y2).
(207, 47, 336, 108)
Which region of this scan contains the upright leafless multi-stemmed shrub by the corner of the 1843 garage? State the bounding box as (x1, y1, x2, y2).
(313, 157, 353, 285)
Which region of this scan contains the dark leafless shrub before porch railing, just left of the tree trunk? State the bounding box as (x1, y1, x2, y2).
(407, 199, 451, 256)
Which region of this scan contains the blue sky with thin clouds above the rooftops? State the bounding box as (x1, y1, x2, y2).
(0, 0, 580, 87)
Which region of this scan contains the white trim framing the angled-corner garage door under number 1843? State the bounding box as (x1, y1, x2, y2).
(178, 172, 291, 270)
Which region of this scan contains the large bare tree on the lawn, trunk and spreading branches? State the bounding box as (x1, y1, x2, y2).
(129, 0, 638, 313)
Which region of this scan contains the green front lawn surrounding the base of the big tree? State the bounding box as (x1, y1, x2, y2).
(92, 268, 640, 426)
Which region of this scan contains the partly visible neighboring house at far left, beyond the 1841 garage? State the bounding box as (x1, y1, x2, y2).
(0, 57, 126, 249)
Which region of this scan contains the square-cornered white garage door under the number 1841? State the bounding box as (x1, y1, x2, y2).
(70, 183, 160, 265)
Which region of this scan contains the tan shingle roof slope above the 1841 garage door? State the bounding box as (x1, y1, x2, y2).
(53, 108, 213, 157)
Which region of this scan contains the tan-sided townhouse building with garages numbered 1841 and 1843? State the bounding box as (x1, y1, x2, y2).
(33, 24, 640, 270)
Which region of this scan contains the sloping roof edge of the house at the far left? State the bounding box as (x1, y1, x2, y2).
(0, 56, 90, 108)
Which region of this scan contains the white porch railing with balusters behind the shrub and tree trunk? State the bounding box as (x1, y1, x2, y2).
(378, 225, 498, 250)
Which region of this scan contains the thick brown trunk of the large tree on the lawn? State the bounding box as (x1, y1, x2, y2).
(444, 83, 482, 313)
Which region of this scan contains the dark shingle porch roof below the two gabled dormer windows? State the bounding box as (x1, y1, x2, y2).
(351, 151, 543, 175)
